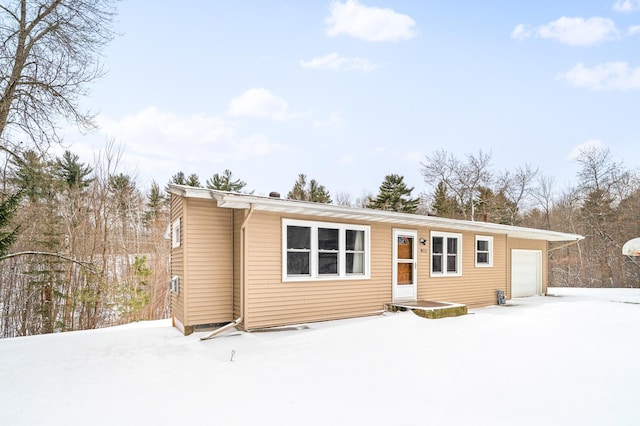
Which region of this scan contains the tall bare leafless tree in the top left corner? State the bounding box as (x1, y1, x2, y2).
(0, 0, 115, 153)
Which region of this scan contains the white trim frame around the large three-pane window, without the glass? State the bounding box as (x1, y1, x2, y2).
(282, 218, 371, 282)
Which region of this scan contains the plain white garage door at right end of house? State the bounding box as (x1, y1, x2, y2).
(511, 250, 542, 297)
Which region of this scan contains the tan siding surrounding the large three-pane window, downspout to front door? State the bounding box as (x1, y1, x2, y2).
(245, 212, 391, 328)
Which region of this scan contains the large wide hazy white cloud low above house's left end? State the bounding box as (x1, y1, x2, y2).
(99, 107, 283, 173)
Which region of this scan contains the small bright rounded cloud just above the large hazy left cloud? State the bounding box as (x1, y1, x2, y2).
(227, 88, 293, 120)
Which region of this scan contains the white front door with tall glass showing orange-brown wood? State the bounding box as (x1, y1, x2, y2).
(392, 229, 418, 302)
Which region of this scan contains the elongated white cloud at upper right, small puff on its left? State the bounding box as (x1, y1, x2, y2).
(511, 16, 620, 46)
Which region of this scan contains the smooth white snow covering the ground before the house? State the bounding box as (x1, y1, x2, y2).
(0, 288, 640, 426)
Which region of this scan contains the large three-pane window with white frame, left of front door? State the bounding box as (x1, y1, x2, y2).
(282, 219, 370, 281)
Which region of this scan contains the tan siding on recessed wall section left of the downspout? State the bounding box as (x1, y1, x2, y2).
(183, 198, 233, 326)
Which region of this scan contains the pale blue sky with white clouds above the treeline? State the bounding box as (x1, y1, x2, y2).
(66, 0, 640, 198)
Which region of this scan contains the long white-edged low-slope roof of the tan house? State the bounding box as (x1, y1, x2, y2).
(169, 184, 584, 241)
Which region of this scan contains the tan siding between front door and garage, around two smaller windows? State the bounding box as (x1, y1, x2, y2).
(418, 228, 507, 308)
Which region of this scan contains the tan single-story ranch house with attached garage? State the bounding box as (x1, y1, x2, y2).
(169, 185, 583, 334)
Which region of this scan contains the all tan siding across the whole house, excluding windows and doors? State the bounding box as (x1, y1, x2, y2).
(171, 188, 560, 329)
